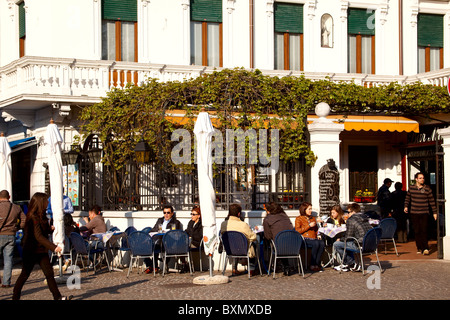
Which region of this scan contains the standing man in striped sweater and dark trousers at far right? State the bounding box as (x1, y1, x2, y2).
(404, 172, 437, 255)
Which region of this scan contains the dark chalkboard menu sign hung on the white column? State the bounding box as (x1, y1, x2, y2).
(319, 159, 340, 215)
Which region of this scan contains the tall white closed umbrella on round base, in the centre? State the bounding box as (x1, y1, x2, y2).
(194, 112, 228, 284)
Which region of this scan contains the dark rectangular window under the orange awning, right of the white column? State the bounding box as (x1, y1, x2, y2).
(348, 146, 378, 201)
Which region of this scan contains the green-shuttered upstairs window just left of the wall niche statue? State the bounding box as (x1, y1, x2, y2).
(274, 2, 303, 71)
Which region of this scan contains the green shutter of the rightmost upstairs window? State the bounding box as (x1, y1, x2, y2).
(417, 13, 444, 48)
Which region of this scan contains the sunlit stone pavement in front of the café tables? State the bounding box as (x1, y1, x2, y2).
(0, 240, 450, 313)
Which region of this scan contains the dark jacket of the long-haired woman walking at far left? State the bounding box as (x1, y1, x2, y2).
(22, 215, 56, 255)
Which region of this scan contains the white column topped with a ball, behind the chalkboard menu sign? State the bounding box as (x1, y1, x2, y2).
(308, 102, 344, 212)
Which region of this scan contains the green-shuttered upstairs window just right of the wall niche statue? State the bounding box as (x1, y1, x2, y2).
(347, 8, 375, 74)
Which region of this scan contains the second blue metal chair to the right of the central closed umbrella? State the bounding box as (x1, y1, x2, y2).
(269, 230, 305, 279)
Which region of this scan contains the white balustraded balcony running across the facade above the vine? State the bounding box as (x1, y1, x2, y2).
(0, 56, 450, 110)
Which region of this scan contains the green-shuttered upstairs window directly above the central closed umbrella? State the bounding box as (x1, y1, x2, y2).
(190, 0, 223, 67)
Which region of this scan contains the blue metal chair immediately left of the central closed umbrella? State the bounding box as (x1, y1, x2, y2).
(161, 230, 192, 276)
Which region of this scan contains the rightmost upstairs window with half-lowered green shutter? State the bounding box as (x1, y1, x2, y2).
(417, 13, 444, 73)
